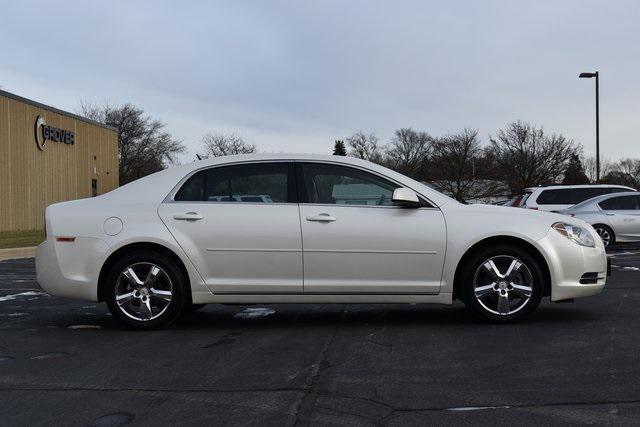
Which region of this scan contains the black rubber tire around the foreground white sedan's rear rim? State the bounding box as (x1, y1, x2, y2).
(105, 251, 188, 330)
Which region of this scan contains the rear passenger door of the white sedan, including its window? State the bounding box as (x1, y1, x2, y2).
(158, 162, 302, 294)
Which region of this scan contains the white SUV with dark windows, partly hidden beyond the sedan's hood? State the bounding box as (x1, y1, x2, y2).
(513, 184, 636, 211)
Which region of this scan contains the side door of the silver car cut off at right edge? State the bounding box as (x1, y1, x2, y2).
(600, 195, 640, 240)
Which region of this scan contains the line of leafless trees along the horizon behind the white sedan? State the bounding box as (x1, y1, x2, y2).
(78, 102, 640, 201)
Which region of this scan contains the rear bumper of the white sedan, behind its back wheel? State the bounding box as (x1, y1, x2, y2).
(36, 237, 109, 301)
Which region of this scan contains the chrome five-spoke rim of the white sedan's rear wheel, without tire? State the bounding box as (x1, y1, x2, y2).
(115, 262, 173, 322)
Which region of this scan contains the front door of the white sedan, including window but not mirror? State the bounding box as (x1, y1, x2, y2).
(298, 162, 446, 294)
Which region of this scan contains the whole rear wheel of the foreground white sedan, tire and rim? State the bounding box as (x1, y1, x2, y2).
(106, 252, 186, 329)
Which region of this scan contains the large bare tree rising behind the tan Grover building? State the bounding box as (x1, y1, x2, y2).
(78, 101, 184, 185)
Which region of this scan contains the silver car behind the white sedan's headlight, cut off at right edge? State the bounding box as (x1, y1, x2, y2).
(560, 192, 640, 247)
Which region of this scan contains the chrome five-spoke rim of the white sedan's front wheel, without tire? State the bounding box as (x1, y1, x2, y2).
(473, 255, 533, 316)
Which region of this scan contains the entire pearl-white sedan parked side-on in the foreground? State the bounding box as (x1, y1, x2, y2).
(36, 155, 607, 329)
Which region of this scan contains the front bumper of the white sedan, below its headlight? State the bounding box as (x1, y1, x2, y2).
(538, 229, 609, 301)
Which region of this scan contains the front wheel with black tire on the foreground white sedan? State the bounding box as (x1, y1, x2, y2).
(458, 244, 547, 323)
